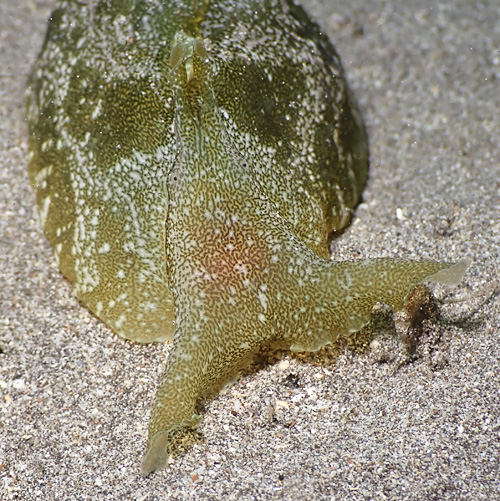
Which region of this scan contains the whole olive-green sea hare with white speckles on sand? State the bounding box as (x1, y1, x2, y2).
(28, 0, 466, 474)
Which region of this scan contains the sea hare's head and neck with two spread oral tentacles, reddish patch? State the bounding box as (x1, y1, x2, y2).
(142, 32, 470, 474)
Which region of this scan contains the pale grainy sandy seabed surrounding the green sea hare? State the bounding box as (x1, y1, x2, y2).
(0, 0, 500, 500)
